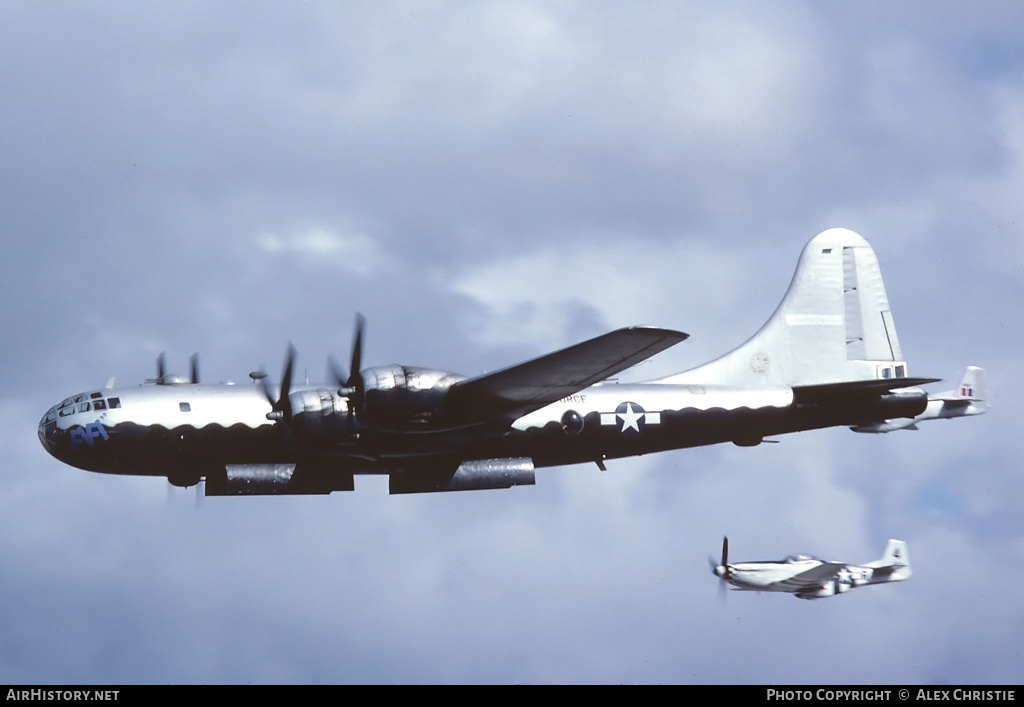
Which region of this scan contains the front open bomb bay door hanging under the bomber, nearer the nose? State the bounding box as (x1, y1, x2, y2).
(206, 464, 355, 496)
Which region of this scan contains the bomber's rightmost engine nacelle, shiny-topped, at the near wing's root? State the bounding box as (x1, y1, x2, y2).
(358, 366, 465, 429)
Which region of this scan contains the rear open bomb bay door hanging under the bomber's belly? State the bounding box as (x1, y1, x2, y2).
(389, 458, 536, 494)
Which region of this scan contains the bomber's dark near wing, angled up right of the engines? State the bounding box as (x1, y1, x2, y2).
(443, 327, 689, 422)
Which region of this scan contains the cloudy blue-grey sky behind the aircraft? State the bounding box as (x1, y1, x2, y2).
(0, 0, 1024, 683)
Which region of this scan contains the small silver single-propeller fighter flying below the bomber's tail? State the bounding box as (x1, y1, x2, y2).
(709, 538, 910, 599)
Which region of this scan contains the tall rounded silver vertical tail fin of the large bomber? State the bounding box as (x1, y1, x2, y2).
(666, 228, 907, 386)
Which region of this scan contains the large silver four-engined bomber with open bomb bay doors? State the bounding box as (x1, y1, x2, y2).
(39, 228, 988, 496)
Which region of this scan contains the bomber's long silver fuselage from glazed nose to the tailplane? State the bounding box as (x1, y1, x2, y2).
(39, 375, 806, 476)
